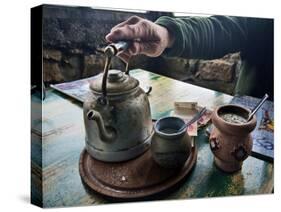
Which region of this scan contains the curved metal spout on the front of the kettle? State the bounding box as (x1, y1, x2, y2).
(87, 110, 116, 142)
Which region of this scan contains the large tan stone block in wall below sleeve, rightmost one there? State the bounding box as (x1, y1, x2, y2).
(195, 59, 236, 82)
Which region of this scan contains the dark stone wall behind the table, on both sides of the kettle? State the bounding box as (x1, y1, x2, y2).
(43, 6, 240, 94)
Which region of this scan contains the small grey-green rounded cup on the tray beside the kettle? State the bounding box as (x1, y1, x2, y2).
(151, 117, 191, 168)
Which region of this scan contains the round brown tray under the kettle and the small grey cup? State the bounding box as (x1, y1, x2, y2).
(79, 142, 197, 199)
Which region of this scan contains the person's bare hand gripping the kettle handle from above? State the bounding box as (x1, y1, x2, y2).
(106, 16, 174, 62)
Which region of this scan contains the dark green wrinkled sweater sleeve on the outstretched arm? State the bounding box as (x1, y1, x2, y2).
(155, 16, 249, 59)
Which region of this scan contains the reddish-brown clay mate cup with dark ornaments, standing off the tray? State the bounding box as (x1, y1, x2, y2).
(209, 104, 257, 172)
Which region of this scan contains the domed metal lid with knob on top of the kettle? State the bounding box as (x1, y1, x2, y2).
(90, 69, 139, 95)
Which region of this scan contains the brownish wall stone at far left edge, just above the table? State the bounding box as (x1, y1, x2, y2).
(43, 60, 64, 82)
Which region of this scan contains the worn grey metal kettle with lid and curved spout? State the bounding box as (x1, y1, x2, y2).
(84, 43, 153, 162)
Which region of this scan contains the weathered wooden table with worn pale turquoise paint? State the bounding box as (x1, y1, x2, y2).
(31, 69, 274, 207)
